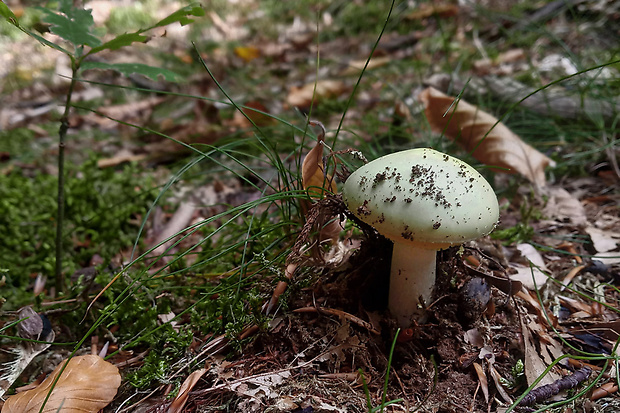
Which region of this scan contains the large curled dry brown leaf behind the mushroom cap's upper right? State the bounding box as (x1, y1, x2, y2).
(420, 87, 555, 188)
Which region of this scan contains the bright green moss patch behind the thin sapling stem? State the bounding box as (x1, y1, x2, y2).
(0, 158, 155, 308)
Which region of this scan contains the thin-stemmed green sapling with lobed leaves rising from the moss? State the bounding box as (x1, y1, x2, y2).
(0, 0, 204, 293)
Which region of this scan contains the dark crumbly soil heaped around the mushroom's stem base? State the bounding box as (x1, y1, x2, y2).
(173, 230, 523, 412)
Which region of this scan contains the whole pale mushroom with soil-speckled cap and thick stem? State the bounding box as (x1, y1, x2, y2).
(342, 148, 499, 327)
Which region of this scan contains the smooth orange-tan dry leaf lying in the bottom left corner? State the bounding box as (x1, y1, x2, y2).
(2, 355, 121, 413)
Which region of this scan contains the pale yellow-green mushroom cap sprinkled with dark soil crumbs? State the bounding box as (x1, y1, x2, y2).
(343, 148, 499, 249)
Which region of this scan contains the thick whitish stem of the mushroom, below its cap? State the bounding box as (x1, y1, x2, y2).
(388, 242, 437, 328)
